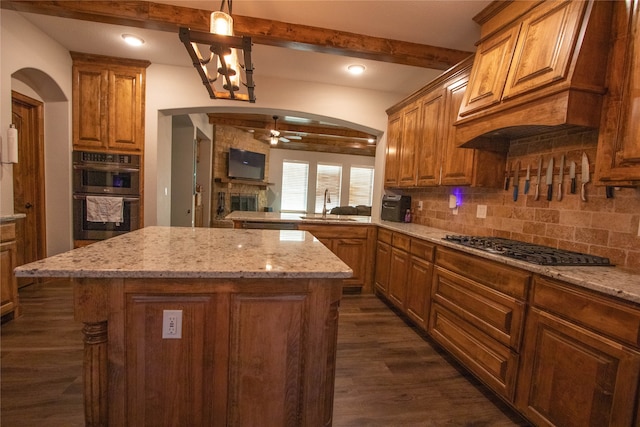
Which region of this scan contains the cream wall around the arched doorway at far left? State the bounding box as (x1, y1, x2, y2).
(0, 9, 72, 255)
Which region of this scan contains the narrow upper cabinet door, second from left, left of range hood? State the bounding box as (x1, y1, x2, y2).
(398, 102, 421, 187)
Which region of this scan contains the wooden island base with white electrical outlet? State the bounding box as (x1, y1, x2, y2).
(76, 279, 342, 427)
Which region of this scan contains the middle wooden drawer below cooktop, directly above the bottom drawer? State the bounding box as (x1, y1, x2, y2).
(432, 267, 525, 351)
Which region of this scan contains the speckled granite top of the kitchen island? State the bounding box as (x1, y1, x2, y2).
(15, 227, 353, 279)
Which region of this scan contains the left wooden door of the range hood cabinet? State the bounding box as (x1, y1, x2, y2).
(459, 25, 520, 118)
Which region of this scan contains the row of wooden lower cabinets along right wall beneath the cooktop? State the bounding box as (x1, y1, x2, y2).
(375, 228, 640, 427)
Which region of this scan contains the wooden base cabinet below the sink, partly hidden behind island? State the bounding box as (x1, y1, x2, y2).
(298, 223, 376, 293)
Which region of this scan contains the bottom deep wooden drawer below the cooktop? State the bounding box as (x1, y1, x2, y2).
(429, 303, 519, 402)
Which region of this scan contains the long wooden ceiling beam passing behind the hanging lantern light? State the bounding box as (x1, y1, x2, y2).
(0, 0, 471, 70)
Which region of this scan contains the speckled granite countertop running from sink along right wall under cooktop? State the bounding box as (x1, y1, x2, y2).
(227, 212, 640, 304)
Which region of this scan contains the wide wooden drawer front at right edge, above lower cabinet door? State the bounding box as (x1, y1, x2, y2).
(531, 276, 640, 348)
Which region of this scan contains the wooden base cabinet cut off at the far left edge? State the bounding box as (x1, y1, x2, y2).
(0, 222, 20, 320)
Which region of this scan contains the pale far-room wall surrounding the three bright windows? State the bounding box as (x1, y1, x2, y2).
(267, 148, 380, 213)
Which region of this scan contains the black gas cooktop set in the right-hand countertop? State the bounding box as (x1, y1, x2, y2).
(444, 235, 612, 266)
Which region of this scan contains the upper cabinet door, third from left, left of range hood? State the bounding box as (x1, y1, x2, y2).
(417, 89, 445, 187)
